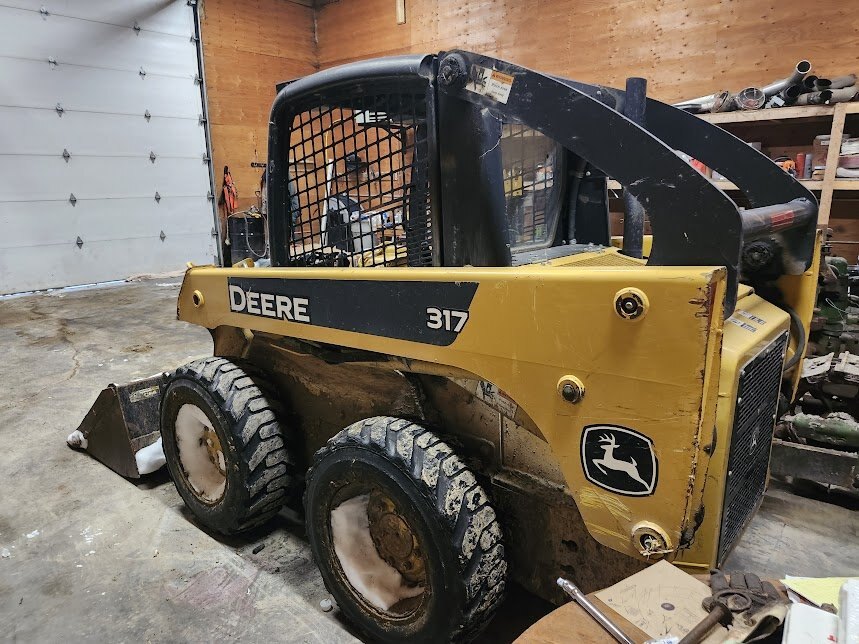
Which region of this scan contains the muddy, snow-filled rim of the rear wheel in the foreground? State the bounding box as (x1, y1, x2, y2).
(330, 489, 429, 619)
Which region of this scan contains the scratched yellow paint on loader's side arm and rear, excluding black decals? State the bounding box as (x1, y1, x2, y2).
(179, 249, 804, 566)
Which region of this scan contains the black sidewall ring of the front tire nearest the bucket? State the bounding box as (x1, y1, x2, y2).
(161, 378, 249, 534)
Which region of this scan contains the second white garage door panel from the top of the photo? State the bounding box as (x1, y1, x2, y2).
(0, 9, 197, 78)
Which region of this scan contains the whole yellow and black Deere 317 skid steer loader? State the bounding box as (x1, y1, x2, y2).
(77, 51, 819, 642)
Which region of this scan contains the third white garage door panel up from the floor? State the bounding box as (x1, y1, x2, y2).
(0, 156, 209, 203)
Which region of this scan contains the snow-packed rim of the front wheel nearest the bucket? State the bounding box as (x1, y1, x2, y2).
(175, 403, 227, 505)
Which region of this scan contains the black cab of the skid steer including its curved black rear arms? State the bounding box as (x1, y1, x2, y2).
(267, 51, 817, 316)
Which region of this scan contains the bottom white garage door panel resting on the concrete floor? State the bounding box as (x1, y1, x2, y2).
(0, 233, 211, 293)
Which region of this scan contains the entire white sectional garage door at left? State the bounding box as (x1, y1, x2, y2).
(0, 0, 217, 293)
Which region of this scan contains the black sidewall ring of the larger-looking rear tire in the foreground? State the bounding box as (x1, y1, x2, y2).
(305, 445, 465, 643)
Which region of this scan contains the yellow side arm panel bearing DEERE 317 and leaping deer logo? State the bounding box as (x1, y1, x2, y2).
(179, 266, 725, 555)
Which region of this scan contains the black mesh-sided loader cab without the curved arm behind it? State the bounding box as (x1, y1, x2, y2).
(268, 56, 609, 267)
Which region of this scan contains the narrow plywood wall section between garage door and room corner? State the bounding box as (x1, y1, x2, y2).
(201, 0, 318, 209)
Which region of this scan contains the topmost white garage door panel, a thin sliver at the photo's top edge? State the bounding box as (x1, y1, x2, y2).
(3, 0, 194, 37)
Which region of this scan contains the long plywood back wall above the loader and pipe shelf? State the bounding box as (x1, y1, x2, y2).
(317, 0, 859, 102)
